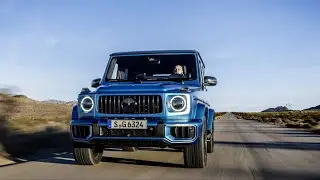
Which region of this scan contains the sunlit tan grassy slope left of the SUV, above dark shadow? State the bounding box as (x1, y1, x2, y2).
(0, 93, 76, 132)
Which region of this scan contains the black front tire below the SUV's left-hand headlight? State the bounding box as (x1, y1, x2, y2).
(73, 144, 103, 165)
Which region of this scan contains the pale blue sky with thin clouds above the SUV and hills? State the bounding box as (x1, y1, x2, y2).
(0, 0, 320, 111)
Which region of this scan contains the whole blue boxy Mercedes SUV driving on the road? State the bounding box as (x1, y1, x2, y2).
(70, 50, 217, 168)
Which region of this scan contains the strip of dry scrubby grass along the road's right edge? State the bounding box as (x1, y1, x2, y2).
(232, 111, 320, 132)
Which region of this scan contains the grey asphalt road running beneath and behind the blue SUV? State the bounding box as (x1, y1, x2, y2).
(0, 114, 320, 180)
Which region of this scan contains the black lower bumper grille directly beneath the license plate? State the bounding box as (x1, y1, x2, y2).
(101, 127, 163, 137)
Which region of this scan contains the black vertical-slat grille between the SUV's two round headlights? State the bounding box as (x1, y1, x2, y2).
(98, 95, 162, 114)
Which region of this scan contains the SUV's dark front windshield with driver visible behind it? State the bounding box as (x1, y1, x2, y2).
(105, 54, 197, 81)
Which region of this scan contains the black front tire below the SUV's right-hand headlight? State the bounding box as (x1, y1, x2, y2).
(183, 119, 208, 168)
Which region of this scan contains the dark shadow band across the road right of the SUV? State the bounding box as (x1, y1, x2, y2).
(215, 141, 320, 151)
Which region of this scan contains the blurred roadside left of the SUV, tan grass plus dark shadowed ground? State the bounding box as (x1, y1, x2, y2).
(0, 93, 72, 156)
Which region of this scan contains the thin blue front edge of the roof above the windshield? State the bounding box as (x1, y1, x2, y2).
(110, 50, 198, 56)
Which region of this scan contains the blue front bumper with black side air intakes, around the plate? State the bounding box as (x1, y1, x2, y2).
(70, 119, 202, 147)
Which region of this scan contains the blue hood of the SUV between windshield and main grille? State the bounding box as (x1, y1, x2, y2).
(96, 82, 199, 93)
